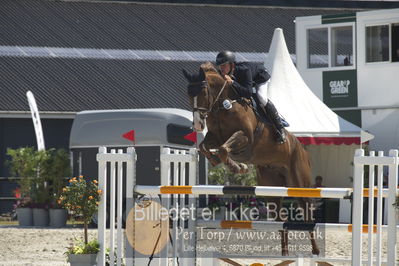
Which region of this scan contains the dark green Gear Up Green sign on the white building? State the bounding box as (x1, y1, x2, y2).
(323, 70, 357, 108)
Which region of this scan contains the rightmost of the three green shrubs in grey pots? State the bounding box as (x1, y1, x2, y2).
(45, 149, 71, 227)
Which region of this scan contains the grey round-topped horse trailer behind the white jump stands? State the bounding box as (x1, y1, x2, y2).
(69, 108, 207, 185)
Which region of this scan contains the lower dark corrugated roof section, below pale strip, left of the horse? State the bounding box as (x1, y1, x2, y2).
(0, 57, 198, 112)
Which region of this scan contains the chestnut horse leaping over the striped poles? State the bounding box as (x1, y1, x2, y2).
(183, 63, 319, 255)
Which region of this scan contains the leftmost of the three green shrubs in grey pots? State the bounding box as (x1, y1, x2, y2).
(6, 147, 37, 226)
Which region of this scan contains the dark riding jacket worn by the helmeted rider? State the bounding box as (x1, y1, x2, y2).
(232, 62, 270, 99)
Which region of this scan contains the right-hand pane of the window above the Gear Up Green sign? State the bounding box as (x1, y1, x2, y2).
(331, 26, 353, 67)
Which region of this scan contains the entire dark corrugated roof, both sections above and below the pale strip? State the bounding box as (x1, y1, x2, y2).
(0, 0, 364, 112)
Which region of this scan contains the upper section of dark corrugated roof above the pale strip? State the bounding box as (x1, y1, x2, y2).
(0, 0, 362, 53)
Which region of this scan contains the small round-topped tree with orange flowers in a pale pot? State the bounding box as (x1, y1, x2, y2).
(59, 176, 102, 265)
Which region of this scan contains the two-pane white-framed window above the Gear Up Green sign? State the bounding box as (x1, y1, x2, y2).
(307, 24, 354, 68)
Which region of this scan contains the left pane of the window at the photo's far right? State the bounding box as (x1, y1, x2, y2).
(366, 25, 389, 63)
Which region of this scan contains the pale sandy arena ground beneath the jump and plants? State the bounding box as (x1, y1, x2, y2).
(0, 226, 399, 266)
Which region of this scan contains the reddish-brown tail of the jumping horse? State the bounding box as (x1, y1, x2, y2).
(290, 135, 312, 187)
